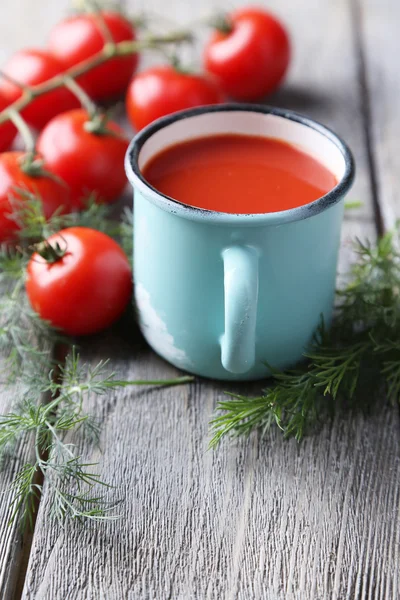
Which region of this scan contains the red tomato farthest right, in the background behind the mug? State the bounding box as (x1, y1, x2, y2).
(204, 8, 290, 100)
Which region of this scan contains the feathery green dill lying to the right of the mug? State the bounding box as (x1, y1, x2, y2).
(210, 227, 400, 446)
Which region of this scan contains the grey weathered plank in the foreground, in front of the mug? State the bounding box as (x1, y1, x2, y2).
(24, 338, 399, 600)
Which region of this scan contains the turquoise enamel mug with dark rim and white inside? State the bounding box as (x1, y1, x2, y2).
(126, 104, 354, 380)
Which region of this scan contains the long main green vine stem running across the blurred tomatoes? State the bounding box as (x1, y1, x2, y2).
(0, 30, 192, 125)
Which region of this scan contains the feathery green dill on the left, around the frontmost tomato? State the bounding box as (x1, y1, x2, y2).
(0, 195, 193, 526)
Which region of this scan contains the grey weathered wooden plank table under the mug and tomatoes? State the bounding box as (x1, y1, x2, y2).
(0, 0, 400, 600)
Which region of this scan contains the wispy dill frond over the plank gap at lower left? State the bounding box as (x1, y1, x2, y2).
(0, 376, 117, 524)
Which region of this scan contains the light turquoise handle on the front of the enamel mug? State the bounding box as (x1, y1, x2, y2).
(221, 245, 258, 373)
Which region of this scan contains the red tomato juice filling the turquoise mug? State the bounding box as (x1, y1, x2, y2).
(142, 134, 337, 214)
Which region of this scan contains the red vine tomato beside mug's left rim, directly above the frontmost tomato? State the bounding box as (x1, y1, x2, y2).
(36, 109, 128, 208)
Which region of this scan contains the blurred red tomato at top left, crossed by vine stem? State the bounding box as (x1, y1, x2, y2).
(48, 11, 138, 99)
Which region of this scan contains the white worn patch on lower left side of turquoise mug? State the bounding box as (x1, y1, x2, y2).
(135, 283, 191, 368)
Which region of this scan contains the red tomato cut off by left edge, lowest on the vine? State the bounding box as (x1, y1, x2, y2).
(0, 152, 69, 242)
